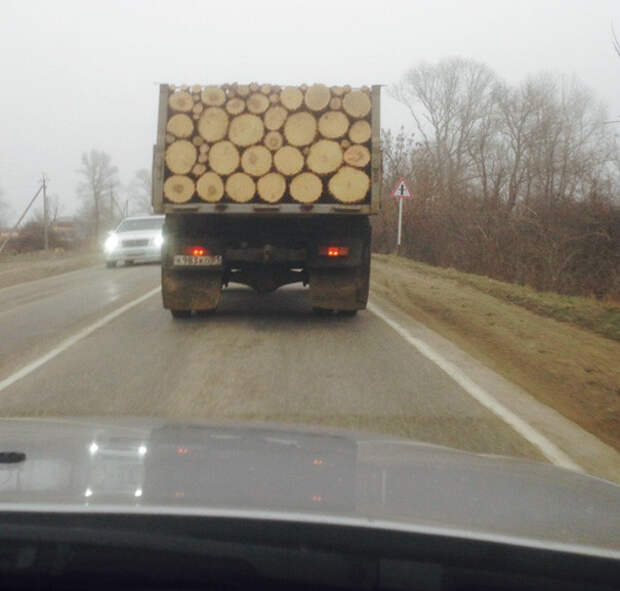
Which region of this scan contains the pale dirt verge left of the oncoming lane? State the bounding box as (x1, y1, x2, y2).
(0, 251, 101, 289)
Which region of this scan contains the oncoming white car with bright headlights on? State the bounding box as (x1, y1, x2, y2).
(103, 215, 165, 268)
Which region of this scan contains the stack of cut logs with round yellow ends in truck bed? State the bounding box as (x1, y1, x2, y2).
(164, 83, 371, 204)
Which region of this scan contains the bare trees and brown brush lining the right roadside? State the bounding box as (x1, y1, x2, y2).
(373, 58, 620, 298)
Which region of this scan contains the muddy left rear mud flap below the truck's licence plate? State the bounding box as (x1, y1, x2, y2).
(161, 266, 222, 310)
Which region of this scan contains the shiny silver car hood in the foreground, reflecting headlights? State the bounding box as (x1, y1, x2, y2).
(0, 419, 620, 556)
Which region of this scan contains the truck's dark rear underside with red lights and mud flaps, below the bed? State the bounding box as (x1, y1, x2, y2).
(162, 214, 370, 317)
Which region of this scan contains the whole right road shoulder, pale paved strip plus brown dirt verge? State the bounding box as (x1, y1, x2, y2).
(372, 257, 620, 480)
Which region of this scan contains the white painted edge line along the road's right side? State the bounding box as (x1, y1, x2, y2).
(368, 303, 584, 472)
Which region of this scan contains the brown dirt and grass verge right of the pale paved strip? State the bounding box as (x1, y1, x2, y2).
(371, 255, 620, 450)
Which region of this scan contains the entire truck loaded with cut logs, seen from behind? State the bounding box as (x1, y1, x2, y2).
(152, 83, 381, 318)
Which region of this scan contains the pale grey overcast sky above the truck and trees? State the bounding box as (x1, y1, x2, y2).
(0, 0, 620, 219)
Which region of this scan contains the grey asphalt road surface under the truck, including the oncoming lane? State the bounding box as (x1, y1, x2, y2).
(0, 265, 612, 476)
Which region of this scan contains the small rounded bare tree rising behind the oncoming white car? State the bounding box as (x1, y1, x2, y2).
(78, 150, 119, 238)
